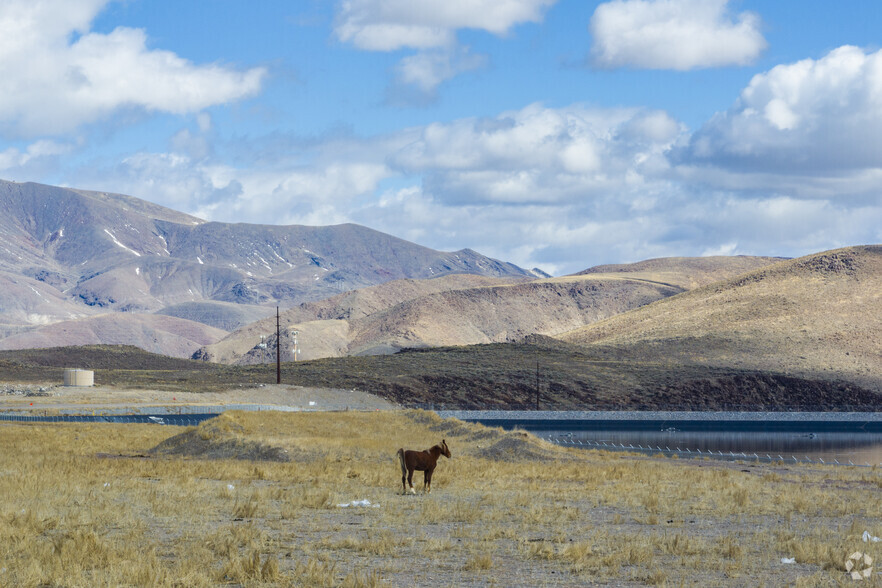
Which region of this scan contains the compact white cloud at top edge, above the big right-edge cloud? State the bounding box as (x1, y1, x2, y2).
(590, 0, 766, 71)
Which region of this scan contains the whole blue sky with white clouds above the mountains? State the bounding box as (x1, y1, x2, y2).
(0, 0, 882, 275)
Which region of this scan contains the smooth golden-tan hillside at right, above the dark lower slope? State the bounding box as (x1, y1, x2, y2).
(560, 246, 882, 391)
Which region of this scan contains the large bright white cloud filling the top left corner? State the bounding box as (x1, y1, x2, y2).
(0, 0, 266, 136)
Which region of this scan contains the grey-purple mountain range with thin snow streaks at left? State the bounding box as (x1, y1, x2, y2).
(0, 181, 538, 348)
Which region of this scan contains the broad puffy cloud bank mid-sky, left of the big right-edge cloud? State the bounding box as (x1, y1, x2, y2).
(390, 104, 684, 203)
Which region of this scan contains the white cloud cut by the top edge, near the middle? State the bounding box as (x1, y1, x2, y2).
(334, 0, 556, 51)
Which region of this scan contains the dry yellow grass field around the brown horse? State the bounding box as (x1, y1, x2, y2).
(0, 411, 882, 586)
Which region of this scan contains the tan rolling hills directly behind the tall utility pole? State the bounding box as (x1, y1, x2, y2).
(198, 258, 775, 363)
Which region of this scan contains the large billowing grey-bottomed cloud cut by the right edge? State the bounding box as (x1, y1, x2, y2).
(682, 46, 882, 178)
